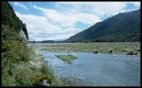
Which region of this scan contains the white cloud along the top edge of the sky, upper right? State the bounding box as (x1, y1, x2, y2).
(55, 1, 140, 17)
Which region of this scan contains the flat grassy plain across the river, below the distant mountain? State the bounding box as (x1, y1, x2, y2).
(42, 42, 141, 54)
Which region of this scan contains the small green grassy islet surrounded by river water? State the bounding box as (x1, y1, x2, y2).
(56, 54, 77, 64)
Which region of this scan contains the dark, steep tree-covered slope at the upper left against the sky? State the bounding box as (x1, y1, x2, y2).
(2, 2, 29, 39)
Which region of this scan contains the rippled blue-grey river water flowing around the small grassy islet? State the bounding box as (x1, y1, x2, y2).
(41, 51, 140, 86)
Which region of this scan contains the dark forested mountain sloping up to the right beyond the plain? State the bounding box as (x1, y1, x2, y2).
(65, 9, 141, 42)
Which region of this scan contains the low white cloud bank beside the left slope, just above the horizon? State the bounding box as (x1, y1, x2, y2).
(16, 12, 81, 40)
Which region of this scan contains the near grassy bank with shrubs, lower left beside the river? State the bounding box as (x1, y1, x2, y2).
(2, 41, 60, 86)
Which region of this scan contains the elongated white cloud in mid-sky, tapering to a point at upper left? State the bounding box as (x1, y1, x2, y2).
(33, 5, 101, 26)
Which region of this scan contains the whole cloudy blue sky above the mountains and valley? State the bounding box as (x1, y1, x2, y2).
(9, 1, 140, 41)
